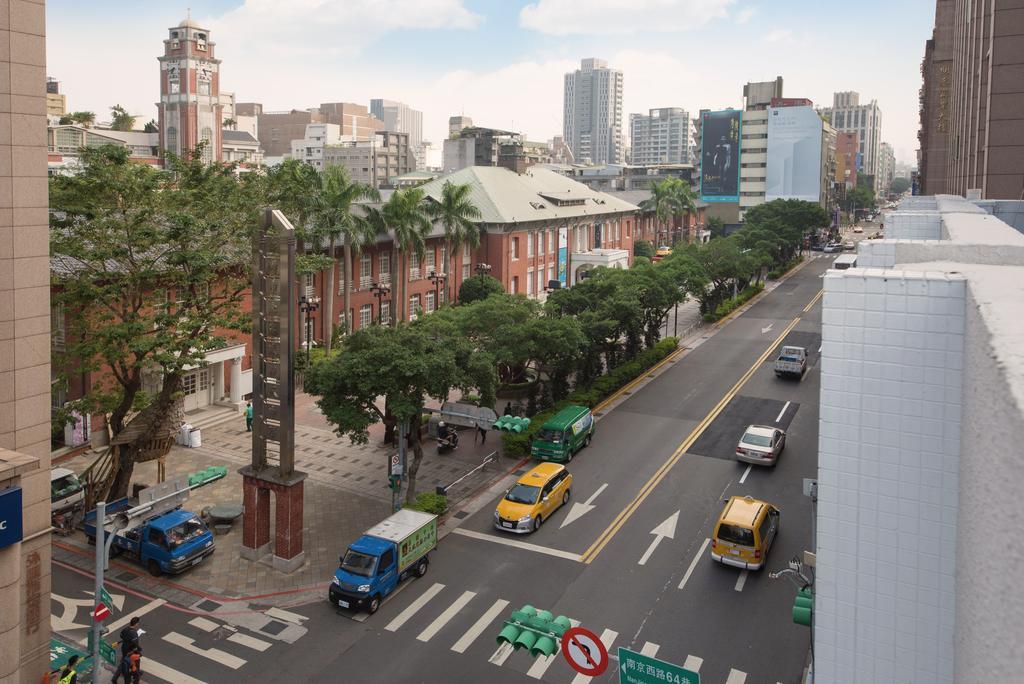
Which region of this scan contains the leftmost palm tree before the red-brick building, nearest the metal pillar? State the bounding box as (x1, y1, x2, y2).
(313, 166, 380, 351)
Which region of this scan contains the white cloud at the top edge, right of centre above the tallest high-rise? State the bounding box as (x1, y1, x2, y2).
(519, 0, 734, 36)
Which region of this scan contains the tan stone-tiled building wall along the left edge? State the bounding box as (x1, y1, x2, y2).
(0, 0, 50, 682)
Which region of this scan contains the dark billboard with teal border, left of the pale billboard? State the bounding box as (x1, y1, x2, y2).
(700, 110, 742, 202)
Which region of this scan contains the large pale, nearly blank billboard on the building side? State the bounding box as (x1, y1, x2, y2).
(765, 102, 821, 202)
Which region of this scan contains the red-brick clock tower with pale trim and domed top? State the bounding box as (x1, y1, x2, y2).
(157, 18, 222, 163)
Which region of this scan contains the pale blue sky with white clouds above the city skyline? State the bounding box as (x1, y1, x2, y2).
(46, 0, 935, 162)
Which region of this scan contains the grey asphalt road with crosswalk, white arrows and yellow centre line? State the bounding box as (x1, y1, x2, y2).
(54, 255, 834, 684)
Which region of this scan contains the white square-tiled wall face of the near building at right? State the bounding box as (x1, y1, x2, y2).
(814, 268, 965, 684)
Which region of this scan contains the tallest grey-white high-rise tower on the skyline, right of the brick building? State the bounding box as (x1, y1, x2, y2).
(562, 57, 625, 164)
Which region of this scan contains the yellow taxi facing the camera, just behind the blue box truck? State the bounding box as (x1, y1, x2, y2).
(495, 462, 572, 535)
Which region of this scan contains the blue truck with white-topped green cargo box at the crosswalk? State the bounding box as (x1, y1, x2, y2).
(328, 509, 437, 613)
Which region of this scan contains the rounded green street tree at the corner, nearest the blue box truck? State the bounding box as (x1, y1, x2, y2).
(305, 316, 495, 503)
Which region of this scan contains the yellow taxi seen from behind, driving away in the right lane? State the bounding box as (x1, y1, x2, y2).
(711, 497, 781, 570)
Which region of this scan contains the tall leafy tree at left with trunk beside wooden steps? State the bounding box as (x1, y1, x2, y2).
(50, 145, 260, 497)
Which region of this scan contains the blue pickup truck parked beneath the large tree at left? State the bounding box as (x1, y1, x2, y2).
(85, 497, 214, 576)
